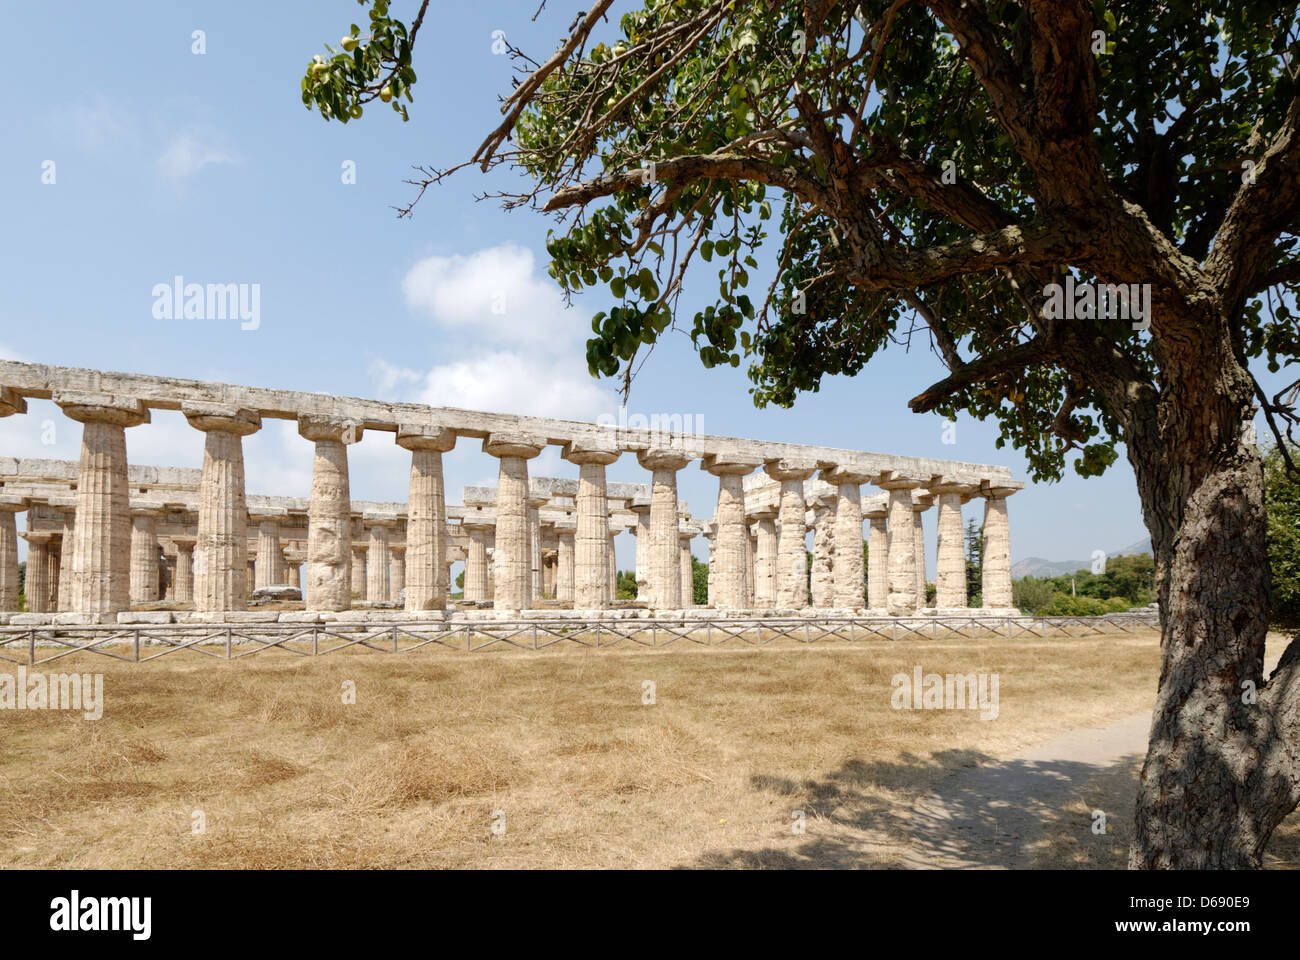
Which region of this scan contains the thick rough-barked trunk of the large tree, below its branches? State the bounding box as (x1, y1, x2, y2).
(1127, 340, 1300, 869)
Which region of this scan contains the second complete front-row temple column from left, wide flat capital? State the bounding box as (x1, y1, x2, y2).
(181, 403, 261, 613)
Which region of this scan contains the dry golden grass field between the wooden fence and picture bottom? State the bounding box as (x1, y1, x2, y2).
(0, 633, 1297, 869)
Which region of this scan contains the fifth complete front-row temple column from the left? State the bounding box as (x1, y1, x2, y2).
(484, 433, 546, 610)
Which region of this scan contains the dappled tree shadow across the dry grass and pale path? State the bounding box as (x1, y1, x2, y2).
(688, 751, 1132, 869)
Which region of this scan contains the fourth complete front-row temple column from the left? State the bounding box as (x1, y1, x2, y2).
(398, 424, 457, 613)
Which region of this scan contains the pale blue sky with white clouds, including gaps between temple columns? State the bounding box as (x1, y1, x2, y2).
(0, 0, 1281, 576)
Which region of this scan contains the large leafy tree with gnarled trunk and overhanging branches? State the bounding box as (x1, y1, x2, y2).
(303, 0, 1300, 868)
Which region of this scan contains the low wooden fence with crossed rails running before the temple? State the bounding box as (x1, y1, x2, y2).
(0, 610, 1160, 666)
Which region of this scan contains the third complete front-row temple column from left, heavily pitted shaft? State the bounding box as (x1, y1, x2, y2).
(298, 415, 361, 610)
